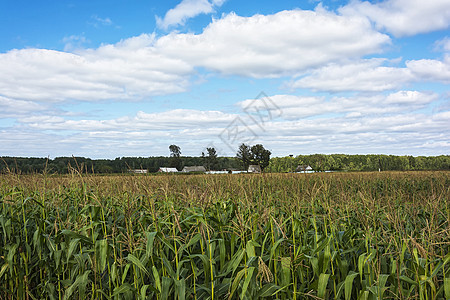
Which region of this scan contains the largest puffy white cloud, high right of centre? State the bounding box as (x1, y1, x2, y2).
(155, 7, 390, 78)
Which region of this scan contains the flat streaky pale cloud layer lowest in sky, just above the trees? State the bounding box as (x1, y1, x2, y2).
(0, 91, 450, 158)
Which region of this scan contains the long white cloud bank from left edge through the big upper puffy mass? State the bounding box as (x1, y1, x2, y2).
(0, 7, 390, 108)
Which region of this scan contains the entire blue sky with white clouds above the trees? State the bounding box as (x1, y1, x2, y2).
(0, 0, 450, 158)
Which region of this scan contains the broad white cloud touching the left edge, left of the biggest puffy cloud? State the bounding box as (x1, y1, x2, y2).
(0, 34, 193, 102)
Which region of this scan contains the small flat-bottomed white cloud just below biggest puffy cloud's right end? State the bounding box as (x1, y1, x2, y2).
(289, 59, 414, 92)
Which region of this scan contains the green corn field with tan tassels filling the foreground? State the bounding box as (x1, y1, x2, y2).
(0, 171, 450, 300)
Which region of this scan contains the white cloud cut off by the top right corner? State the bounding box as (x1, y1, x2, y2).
(340, 0, 450, 37)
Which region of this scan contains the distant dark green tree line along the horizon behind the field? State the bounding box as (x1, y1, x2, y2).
(0, 151, 450, 174)
